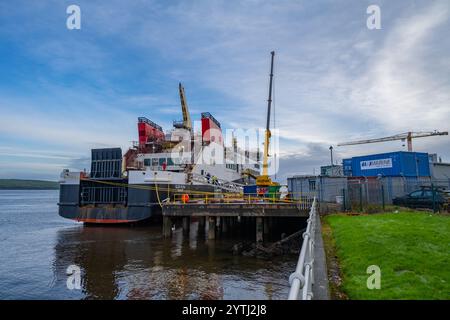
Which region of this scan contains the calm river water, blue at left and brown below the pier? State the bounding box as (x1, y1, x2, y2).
(0, 190, 297, 299)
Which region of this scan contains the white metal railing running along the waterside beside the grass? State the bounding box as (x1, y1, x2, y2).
(288, 198, 317, 300)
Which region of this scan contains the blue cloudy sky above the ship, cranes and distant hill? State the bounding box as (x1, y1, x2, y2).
(0, 0, 450, 180)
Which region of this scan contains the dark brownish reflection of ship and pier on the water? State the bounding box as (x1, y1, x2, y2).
(53, 222, 296, 299)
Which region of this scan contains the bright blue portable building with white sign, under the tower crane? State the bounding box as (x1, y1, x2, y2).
(342, 151, 430, 177)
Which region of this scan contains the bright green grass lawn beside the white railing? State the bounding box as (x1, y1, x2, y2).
(324, 212, 450, 299)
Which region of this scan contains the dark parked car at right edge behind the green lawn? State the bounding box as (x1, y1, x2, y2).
(392, 187, 450, 210)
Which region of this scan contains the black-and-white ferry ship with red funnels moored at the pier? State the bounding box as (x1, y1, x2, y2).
(58, 83, 259, 223)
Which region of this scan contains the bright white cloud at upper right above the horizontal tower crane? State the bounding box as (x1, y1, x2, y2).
(351, 2, 450, 132)
